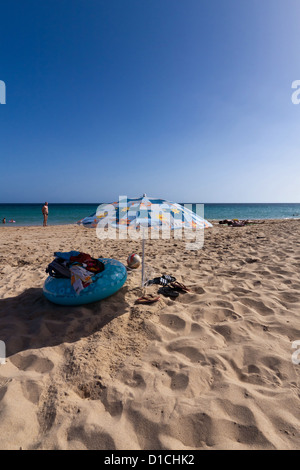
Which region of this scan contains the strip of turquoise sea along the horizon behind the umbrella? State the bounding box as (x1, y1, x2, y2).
(0, 203, 300, 227)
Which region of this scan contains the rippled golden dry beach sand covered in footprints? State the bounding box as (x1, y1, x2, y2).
(0, 220, 300, 450)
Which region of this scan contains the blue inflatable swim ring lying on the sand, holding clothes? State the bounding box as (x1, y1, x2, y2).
(43, 258, 127, 305)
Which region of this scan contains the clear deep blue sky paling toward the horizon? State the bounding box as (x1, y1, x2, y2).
(0, 0, 300, 203)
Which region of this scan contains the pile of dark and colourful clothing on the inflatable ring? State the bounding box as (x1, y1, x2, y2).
(46, 251, 104, 295)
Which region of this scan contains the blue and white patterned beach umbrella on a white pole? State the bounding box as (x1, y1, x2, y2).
(78, 194, 212, 287)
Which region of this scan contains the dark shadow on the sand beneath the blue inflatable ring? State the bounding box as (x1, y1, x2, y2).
(0, 286, 130, 358)
